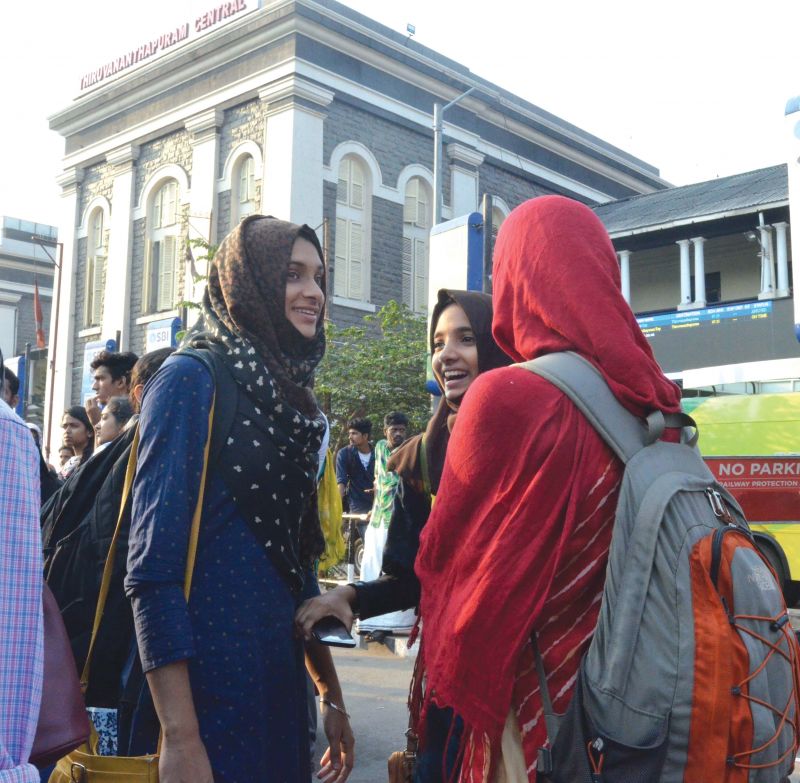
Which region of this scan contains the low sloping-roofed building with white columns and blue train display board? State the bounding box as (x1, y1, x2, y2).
(595, 164, 800, 396)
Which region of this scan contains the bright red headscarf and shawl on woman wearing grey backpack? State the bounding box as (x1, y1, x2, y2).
(416, 196, 680, 781)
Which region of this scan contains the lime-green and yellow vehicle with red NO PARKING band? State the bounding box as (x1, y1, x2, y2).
(684, 393, 800, 605)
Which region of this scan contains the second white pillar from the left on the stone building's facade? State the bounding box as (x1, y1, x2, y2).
(101, 144, 139, 351)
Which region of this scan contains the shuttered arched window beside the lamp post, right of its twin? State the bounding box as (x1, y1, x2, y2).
(403, 177, 432, 313)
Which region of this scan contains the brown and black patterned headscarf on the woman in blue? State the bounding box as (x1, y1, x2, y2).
(184, 215, 326, 591)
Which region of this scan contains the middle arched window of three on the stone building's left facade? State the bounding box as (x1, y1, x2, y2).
(145, 179, 180, 313)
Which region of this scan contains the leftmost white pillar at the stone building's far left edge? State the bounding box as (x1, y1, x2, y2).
(44, 168, 83, 456)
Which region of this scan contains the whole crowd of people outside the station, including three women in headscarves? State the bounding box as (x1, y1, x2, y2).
(0, 197, 788, 783)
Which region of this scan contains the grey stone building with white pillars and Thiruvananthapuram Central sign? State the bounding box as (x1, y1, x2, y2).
(49, 0, 667, 454)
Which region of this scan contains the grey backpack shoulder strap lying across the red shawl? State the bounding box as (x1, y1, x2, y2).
(515, 351, 697, 463)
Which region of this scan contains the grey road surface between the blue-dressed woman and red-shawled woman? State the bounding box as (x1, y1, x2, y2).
(315, 644, 414, 783)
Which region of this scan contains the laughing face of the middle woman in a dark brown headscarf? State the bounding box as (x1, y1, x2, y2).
(431, 303, 478, 402)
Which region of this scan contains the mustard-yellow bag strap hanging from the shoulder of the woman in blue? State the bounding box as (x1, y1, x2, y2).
(81, 394, 216, 692)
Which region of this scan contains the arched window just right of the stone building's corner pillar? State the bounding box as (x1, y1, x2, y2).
(333, 156, 371, 301)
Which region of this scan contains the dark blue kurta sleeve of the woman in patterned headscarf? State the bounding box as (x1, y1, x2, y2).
(125, 356, 214, 672)
